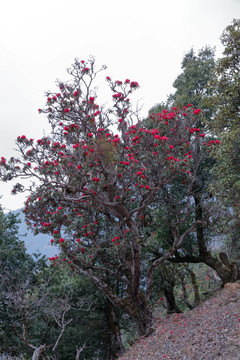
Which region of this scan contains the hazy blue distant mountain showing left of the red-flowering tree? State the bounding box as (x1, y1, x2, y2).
(12, 209, 59, 257)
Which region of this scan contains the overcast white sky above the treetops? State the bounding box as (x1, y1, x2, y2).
(0, 0, 240, 210)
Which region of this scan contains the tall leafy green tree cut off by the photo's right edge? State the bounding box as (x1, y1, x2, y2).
(206, 19, 240, 259)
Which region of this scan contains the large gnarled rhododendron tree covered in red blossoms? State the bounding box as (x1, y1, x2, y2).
(0, 58, 218, 335)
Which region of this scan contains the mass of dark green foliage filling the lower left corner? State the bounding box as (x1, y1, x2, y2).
(0, 205, 117, 360)
